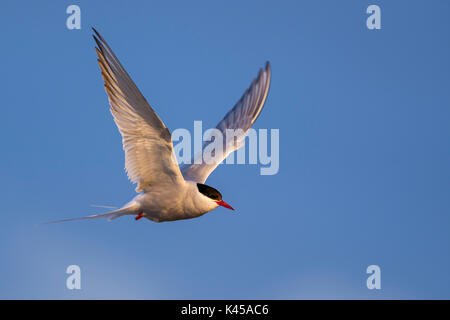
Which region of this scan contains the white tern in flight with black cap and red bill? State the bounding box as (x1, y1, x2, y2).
(51, 29, 271, 222)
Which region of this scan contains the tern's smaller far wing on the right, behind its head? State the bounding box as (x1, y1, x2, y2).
(181, 62, 271, 183)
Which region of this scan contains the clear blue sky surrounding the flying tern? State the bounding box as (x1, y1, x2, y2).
(0, 0, 450, 299)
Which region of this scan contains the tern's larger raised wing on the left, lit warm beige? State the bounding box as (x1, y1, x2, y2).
(94, 29, 183, 192)
